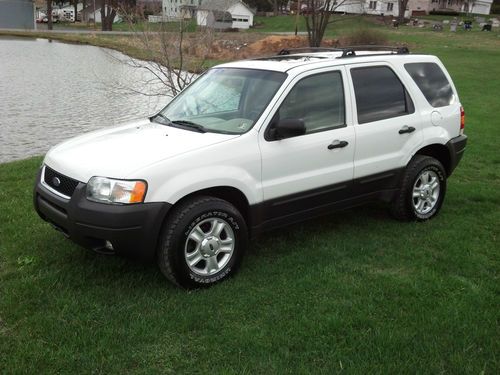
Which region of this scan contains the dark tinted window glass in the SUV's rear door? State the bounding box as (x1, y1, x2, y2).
(351, 66, 415, 124)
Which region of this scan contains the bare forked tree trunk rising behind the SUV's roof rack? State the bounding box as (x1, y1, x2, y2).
(303, 0, 366, 47)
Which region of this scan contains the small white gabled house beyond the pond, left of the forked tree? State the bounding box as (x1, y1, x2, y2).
(196, 0, 255, 29)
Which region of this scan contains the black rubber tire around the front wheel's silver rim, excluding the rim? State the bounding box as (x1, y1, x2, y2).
(170, 205, 247, 288)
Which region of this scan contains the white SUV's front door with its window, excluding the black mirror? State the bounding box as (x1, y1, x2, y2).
(259, 69, 355, 225)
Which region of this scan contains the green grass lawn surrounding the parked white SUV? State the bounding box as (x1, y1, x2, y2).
(0, 18, 500, 374)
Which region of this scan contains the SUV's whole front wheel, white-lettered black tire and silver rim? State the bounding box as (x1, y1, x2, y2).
(158, 196, 248, 289)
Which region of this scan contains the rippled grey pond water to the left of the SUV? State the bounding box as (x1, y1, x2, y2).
(0, 37, 170, 163)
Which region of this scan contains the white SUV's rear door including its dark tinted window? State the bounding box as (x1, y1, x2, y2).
(349, 63, 423, 187)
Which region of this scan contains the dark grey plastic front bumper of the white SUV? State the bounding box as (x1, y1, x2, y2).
(33, 169, 171, 260)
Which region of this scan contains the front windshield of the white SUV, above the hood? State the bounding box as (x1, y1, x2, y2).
(158, 68, 286, 134)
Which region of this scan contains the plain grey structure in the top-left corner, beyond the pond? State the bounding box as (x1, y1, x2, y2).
(0, 0, 35, 29)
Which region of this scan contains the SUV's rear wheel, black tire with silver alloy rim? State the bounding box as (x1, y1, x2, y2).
(391, 155, 446, 221)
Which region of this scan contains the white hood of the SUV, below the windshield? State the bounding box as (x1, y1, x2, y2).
(44, 120, 238, 182)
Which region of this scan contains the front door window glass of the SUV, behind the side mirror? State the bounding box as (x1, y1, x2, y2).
(277, 71, 345, 134)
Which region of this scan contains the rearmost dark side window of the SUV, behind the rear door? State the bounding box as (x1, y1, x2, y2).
(405, 63, 454, 107)
